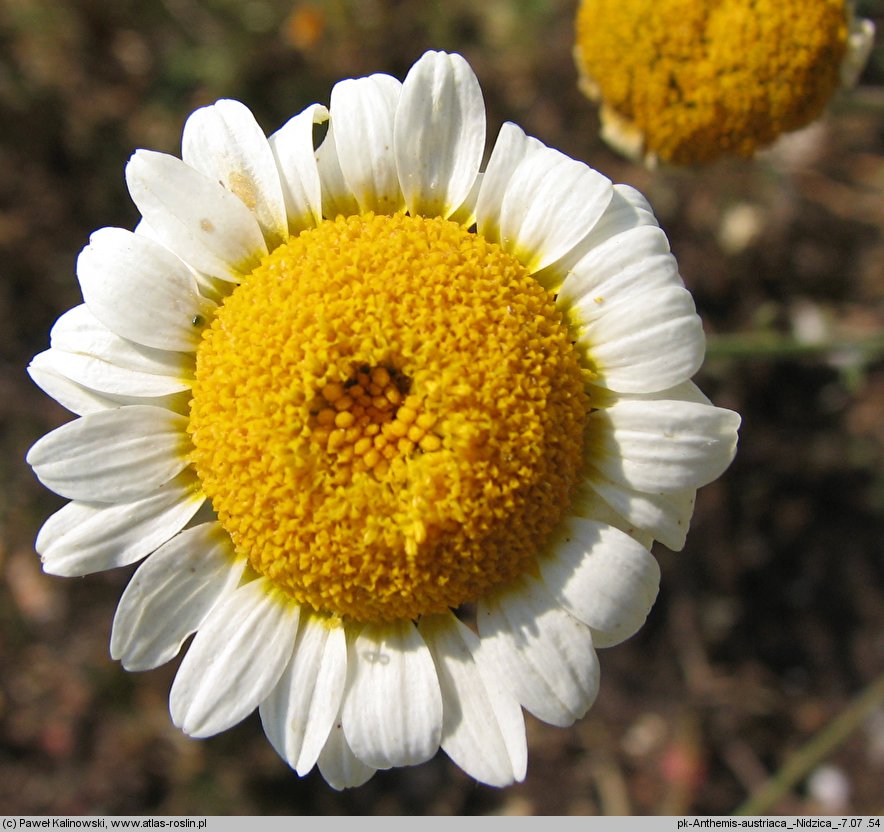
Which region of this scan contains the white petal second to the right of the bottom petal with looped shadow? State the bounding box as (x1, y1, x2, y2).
(479, 578, 599, 727)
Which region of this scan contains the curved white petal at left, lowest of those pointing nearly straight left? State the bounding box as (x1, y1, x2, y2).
(36, 472, 205, 577)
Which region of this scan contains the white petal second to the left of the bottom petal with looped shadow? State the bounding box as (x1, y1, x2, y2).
(169, 578, 300, 737)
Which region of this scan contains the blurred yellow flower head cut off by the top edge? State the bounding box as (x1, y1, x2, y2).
(574, 0, 874, 164)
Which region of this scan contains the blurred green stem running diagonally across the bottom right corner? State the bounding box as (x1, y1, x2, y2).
(734, 673, 884, 815)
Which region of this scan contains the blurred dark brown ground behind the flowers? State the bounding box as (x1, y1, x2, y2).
(0, 0, 884, 814)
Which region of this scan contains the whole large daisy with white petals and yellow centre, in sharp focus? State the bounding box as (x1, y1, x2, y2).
(28, 52, 739, 789)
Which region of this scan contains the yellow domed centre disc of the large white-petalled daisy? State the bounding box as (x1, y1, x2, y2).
(189, 214, 588, 621)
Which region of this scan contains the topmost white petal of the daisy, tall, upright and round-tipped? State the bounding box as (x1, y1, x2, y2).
(394, 52, 485, 218)
